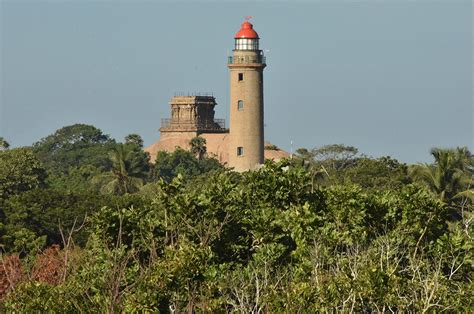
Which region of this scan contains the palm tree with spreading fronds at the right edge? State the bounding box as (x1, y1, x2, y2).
(410, 147, 474, 203)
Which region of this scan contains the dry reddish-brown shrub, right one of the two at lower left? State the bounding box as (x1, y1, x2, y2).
(31, 245, 66, 285)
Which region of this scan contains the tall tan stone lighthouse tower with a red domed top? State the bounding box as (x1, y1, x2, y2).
(227, 21, 266, 172)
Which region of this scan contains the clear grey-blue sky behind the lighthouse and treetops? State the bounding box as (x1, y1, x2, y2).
(0, 0, 474, 162)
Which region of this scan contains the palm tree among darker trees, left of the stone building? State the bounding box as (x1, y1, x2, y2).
(94, 144, 148, 195)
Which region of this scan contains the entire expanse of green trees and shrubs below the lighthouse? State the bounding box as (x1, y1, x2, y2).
(0, 126, 474, 313)
